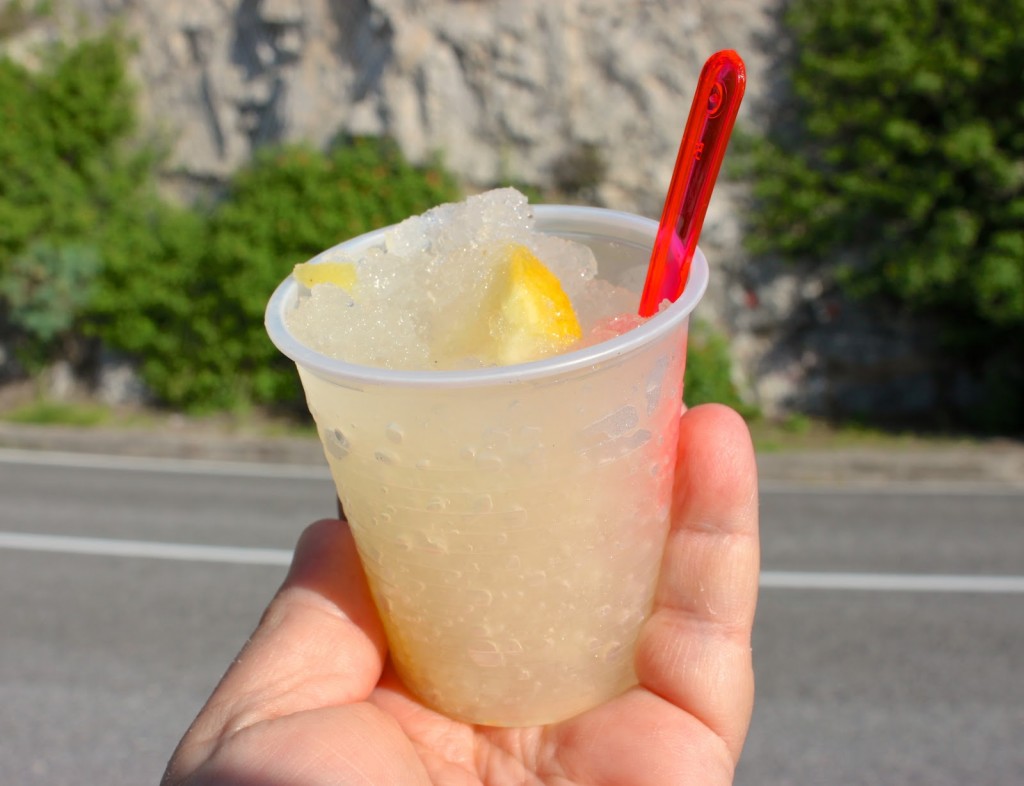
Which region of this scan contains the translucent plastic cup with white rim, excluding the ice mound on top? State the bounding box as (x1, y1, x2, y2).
(266, 206, 709, 726)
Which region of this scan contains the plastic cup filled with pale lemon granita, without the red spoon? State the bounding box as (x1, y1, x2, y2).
(267, 189, 708, 726)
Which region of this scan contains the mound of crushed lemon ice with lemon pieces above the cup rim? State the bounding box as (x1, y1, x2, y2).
(289, 188, 639, 370)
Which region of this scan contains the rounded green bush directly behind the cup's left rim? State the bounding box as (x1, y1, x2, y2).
(96, 139, 458, 409)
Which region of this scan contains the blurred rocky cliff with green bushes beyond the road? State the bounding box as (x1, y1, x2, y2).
(0, 0, 1024, 434)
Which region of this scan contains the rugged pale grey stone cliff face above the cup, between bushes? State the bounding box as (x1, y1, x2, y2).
(90, 0, 768, 216)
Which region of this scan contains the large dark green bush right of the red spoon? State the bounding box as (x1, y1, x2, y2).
(749, 0, 1024, 429)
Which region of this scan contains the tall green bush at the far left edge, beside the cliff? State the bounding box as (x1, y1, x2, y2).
(0, 30, 161, 367)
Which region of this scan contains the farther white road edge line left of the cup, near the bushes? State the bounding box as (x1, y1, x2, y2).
(0, 448, 331, 480)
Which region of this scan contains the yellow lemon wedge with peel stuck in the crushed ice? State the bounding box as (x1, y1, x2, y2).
(488, 245, 583, 365)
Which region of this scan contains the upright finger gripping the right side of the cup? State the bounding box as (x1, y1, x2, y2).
(636, 405, 760, 760)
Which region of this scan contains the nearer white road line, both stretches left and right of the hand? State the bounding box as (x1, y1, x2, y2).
(0, 532, 1024, 595)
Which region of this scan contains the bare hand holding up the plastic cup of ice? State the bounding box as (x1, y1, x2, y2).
(163, 405, 759, 786)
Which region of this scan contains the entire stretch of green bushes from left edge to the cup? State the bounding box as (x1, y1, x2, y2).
(0, 30, 459, 409)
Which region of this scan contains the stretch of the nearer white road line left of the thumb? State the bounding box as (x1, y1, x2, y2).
(0, 532, 292, 565)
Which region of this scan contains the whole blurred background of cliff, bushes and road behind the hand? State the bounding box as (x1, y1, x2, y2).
(0, 0, 1024, 786)
